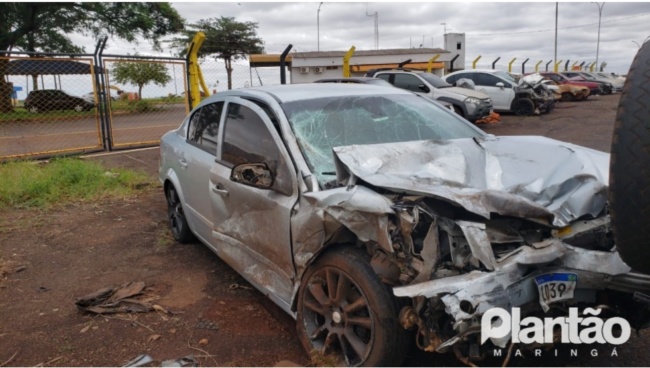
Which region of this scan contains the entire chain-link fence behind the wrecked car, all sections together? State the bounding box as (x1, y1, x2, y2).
(0, 48, 289, 160)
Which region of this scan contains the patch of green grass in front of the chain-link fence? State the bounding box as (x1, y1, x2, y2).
(0, 158, 156, 209)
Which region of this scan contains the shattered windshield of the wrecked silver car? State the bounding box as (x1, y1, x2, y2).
(282, 95, 483, 183)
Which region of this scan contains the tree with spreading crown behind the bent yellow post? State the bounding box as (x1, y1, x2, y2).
(174, 17, 264, 89)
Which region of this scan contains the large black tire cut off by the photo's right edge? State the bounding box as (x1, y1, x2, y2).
(609, 42, 650, 274)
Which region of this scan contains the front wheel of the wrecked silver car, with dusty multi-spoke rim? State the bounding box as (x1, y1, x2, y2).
(297, 248, 408, 366)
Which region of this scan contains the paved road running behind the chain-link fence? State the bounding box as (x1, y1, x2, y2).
(0, 105, 186, 158)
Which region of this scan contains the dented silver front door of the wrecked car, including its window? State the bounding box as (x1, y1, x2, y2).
(209, 97, 298, 310)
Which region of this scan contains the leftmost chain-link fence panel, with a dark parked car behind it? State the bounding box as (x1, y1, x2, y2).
(0, 56, 102, 158)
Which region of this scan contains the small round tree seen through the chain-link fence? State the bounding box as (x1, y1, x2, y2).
(112, 61, 172, 98)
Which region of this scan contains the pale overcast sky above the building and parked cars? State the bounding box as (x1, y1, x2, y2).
(79, 1, 650, 74)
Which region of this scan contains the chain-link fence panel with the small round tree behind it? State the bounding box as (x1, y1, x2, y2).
(96, 57, 188, 148)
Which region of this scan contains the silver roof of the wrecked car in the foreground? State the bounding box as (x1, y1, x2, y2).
(203, 83, 413, 103)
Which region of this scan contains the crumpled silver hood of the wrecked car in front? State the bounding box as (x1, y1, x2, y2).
(334, 136, 609, 227)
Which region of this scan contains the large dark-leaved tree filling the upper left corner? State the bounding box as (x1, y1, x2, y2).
(0, 2, 185, 112)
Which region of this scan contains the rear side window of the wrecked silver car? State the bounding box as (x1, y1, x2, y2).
(187, 102, 224, 156)
